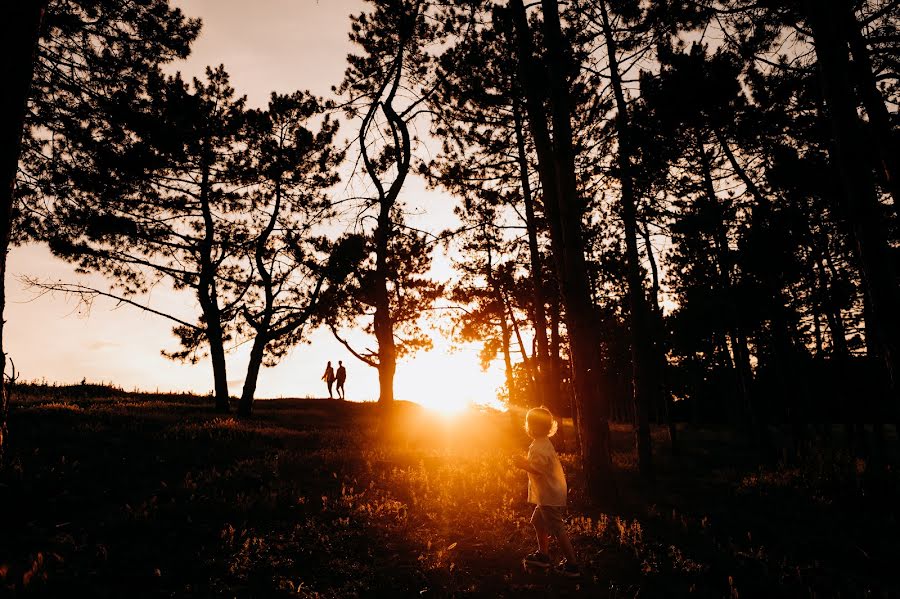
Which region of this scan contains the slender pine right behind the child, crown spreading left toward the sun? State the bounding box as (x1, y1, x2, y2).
(426, 12, 556, 413)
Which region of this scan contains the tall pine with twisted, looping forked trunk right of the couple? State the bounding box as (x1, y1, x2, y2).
(329, 0, 441, 413)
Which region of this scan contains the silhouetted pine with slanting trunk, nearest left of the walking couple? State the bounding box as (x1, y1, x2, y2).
(238, 92, 348, 416)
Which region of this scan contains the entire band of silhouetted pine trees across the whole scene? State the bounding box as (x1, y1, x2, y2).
(0, 0, 900, 508)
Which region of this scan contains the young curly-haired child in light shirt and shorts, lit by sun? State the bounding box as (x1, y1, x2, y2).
(516, 407, 580, 577)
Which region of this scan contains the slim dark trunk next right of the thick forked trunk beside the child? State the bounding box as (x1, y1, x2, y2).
(599, 0, 654, 478)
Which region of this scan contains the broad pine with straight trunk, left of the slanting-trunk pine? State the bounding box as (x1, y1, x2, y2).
(36, 67, 249, 411)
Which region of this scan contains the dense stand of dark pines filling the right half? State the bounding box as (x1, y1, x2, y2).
(423, 0, 900, 498)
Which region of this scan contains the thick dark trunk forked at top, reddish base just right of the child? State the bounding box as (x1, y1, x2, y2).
(510, 0, 616, 503)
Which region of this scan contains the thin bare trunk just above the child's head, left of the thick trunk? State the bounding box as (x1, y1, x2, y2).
(513, 102, 559, 408)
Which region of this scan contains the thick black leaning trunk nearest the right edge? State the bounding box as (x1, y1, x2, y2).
(804, 0, 900, 413)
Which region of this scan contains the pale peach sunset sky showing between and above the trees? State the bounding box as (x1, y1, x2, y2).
(6, 0, 503, 406)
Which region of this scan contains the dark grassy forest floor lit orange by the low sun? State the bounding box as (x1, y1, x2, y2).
(0, 386, 900, 598)
